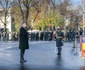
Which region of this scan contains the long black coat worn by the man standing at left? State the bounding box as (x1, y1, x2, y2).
(19, 27, 29, 49)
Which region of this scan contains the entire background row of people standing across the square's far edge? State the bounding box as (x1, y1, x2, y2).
(0, 29, 83, 41)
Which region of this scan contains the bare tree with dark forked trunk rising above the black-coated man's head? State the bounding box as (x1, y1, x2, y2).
(16, 0, 32, 24)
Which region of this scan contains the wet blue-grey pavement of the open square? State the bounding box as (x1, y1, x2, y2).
(0, 41, 85, 70)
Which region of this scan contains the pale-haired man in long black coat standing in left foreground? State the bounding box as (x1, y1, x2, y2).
(19, 23, 29, 63)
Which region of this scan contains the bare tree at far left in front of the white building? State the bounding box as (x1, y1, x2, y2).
(0, 0, 12, 32)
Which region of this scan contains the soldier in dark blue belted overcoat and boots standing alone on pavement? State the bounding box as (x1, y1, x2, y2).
(56, 28, 64, 55)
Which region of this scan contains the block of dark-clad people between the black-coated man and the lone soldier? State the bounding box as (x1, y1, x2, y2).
(29, 32, 53, 41)
